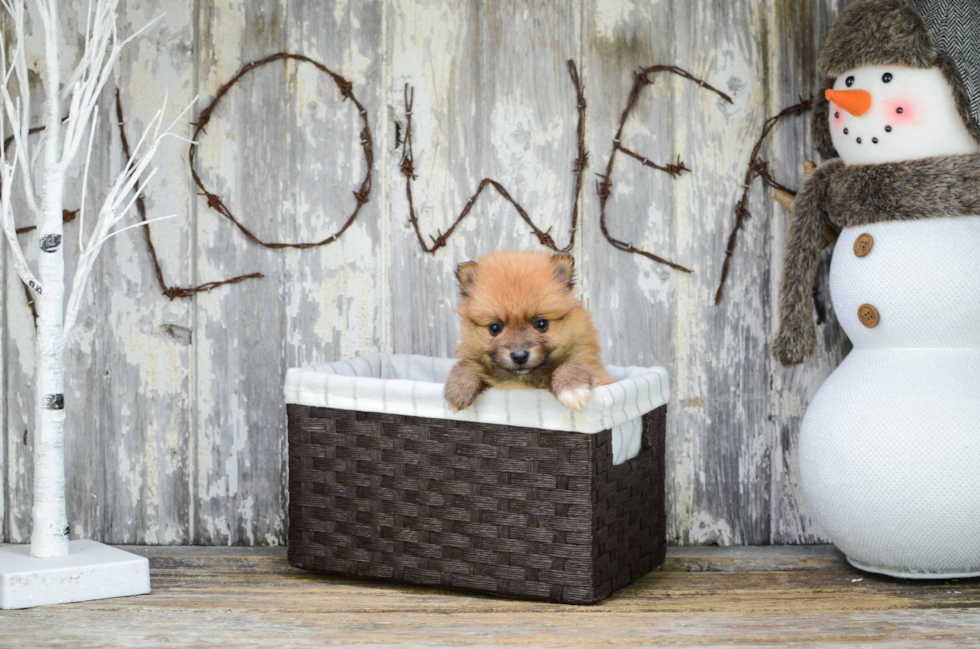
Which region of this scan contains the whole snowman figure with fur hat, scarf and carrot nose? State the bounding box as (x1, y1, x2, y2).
(773, 0, 980, 578)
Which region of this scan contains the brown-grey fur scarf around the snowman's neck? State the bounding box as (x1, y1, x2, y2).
(773, 155, 980, 365)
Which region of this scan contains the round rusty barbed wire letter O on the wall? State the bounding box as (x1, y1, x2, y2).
(187, 52, 374, 249)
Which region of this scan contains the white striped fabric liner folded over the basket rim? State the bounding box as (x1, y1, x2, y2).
(284, 354, 670, 464)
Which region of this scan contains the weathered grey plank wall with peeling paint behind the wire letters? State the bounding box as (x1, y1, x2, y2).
(0, 0, 847, 544)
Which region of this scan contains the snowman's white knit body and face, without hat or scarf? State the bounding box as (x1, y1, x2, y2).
(800, 66, 980, 578)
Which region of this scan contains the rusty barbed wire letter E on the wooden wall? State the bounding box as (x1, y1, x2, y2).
(596, 65, 732, 273)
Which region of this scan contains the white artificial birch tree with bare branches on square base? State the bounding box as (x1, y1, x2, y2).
(0, 0, 190, 608)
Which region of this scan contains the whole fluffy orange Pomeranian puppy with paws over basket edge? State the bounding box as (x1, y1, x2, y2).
(445, 250, 612, 412)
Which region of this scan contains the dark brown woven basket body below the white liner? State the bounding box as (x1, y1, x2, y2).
(287, 404, 667, 604)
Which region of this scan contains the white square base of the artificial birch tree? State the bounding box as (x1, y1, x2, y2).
(0, 541, 150, 609)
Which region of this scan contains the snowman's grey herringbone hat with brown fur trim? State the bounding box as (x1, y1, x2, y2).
(813, 0, 980, 158)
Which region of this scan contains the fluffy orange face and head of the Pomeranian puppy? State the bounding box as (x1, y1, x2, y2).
(456, 251, 581, 380)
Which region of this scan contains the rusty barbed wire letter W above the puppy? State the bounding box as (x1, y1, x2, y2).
(400, 60, 589, 255)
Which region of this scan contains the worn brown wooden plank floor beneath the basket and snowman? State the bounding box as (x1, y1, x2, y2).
(0, 546, 980, 647)
